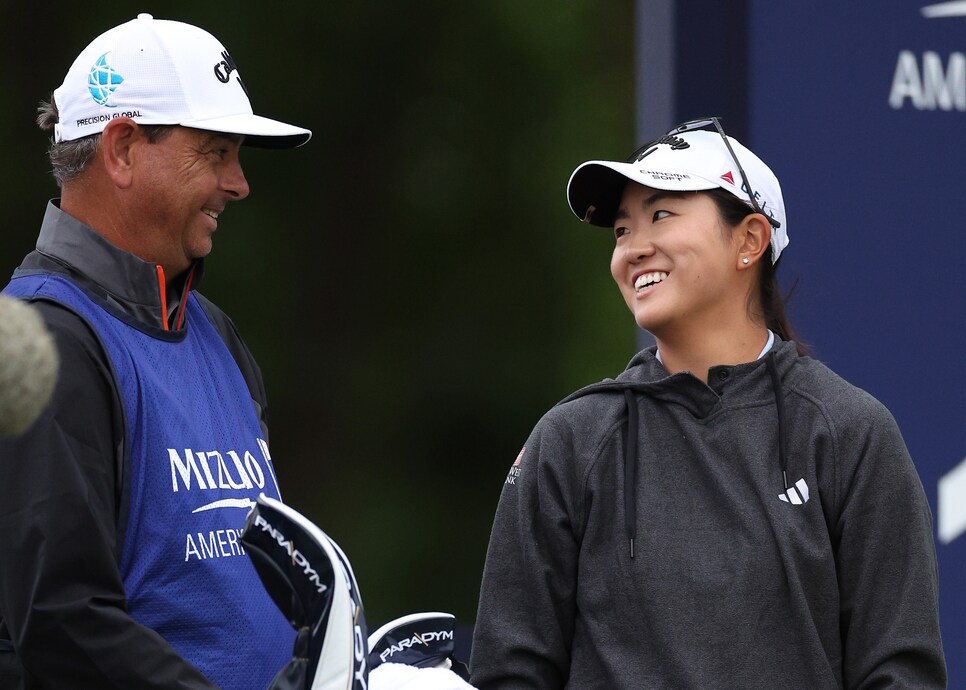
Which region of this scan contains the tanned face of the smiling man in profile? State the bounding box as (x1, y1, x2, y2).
(131, 127, 248, 278)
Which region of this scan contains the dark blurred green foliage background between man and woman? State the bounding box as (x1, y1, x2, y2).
(0, 0, 635, 624)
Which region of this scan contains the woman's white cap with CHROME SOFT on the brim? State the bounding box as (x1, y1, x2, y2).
(567, 130, 788, 261)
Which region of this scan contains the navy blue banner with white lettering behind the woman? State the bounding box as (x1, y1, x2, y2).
(747, 0, 966, 676)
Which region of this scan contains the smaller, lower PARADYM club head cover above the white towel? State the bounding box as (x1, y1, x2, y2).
(369, 611, 469, 680)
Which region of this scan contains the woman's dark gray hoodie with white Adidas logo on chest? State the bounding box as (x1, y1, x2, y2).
(471, 341, 946, 690)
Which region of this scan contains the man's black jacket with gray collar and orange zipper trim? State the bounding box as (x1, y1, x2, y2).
(0, 201, 268, 690)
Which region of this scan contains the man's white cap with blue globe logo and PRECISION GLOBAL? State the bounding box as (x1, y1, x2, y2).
(54, 14, 312, 148)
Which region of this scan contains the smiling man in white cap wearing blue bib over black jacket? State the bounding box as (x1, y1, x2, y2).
(0, 15, 311, 689)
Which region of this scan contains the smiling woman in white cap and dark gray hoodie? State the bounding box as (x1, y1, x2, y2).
(471, 118, 946, 690)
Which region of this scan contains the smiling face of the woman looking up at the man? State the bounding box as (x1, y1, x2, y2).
(610, 182, 738, 338)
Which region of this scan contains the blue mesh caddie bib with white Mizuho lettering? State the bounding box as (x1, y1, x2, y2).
(4, 274, 294, 690)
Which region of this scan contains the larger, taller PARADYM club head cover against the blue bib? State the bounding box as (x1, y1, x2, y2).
(241, 495, 368, 690)
